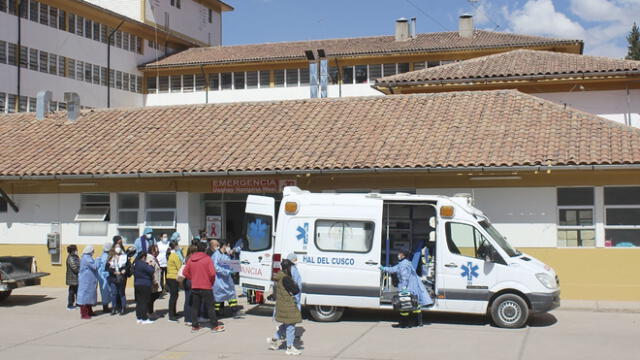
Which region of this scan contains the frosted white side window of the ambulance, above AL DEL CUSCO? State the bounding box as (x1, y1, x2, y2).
(315, 220, 374, 253)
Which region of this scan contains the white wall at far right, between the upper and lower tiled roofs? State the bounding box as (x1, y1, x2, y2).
(533, 89, 640, 127)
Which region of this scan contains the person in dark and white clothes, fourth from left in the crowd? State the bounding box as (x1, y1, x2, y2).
(105, 243, 131, 315)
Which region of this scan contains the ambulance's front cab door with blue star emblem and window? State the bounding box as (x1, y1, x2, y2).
(436, 221, 500, 313)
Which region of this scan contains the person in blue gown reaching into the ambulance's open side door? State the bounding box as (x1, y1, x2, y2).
(380, 250, 433, 327)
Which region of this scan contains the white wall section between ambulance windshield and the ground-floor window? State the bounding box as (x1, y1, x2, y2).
(416, 188, 557, 247)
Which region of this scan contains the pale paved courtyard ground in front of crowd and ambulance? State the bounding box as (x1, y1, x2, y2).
(0, 287, 640, 360)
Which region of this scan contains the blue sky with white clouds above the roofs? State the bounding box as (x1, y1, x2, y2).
(222, 0, 640, 58)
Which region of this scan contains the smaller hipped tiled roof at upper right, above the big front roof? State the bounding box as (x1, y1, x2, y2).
(376, 49, 640, 86)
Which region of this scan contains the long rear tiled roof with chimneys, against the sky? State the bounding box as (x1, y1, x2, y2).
(145, 31, 582, 68)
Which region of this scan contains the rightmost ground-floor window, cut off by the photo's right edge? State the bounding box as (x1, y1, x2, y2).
(604, 186, 640, 247)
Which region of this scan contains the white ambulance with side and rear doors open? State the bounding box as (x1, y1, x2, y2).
(240, 187, 560, 328)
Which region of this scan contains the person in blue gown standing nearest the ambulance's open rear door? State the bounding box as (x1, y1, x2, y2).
(209, 240, 238, 315)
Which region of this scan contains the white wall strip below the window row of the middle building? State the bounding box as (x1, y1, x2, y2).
(145, 84, 383, 106)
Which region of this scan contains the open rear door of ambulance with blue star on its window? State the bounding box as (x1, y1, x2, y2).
(240, 195, 275, 290)
